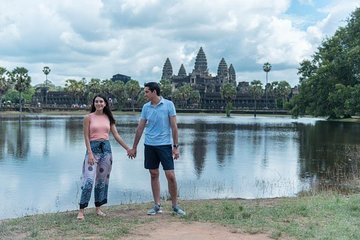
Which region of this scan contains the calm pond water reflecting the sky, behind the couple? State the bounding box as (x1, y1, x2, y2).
(0, 115, 360, 219)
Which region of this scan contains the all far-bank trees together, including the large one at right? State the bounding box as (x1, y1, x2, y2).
(4, 8, 360, 118)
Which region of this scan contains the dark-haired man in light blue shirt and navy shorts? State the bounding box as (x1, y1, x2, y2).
(129, 82, 186, 216)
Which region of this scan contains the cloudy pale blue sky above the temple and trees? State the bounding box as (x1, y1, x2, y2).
(0, 0, 360, 86)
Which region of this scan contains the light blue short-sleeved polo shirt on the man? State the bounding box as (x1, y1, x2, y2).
(140, 97, 176, 146)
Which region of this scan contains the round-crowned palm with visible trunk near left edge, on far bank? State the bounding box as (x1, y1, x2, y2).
(8, 67, 31, 112)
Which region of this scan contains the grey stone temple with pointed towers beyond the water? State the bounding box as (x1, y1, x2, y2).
(161, 47, 274, 109)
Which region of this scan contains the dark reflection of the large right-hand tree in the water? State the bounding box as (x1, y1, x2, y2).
(297, 122, 360, 188)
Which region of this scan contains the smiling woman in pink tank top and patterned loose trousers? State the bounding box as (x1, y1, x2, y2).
(77, 95, 130, 220)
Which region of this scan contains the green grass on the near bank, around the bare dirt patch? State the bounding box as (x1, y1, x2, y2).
(0, 192, 360, 240)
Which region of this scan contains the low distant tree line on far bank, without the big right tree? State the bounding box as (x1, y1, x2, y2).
(0, 67, 291, 116)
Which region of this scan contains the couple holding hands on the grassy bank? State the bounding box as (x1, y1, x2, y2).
(77, 82, 186, 220)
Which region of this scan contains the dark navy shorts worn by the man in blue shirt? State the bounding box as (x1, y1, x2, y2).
(144, 144, 174, 170)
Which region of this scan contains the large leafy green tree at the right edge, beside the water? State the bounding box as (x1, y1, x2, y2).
(290, 8, 360, 118)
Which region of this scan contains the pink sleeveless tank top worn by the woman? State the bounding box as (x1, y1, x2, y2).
(89, 113, 110, 141)
